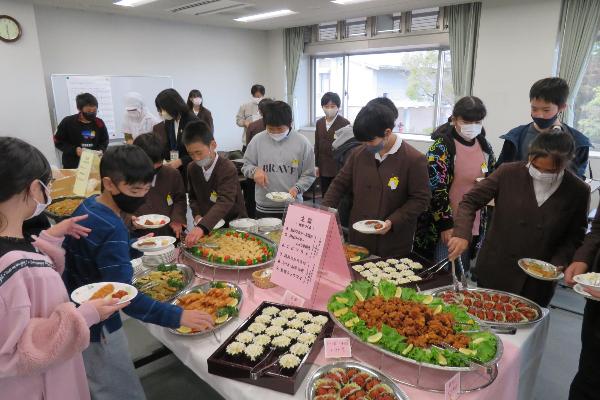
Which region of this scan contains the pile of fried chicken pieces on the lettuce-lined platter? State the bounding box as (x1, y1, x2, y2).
(352, 296, 470, 348)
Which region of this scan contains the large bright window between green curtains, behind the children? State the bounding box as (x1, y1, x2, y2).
(313, 49, 453, 135)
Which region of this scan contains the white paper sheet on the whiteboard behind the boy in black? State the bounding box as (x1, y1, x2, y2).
(67, 76, 117, 139)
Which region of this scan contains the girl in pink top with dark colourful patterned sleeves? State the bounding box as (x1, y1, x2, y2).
(415, 96, 495, 270)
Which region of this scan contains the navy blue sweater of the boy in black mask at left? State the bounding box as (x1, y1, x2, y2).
(63, 196, 182, 342)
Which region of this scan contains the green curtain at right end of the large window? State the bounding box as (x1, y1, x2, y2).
(445, 3, 481, 99)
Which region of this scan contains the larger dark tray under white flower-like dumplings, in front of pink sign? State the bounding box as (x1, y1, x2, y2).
(207, 301, 334, 395)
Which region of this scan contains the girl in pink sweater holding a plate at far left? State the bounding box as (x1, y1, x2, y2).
(0, 137, 127, 400)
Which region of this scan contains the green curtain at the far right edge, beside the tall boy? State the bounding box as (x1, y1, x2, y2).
(558, 0, 600, 124)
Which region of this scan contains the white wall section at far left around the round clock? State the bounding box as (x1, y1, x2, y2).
(0, 0, 57, 164)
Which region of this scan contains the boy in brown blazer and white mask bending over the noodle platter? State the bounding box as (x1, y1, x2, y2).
(183, 121, 246, 246)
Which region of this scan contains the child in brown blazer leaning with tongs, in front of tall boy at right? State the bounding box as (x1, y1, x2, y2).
(448, 130, 590, 307)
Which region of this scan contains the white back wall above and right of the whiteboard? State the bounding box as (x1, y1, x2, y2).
(35, 6, 272, 150)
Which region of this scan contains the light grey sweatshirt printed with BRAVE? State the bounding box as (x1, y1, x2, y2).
(242, 131, 315, 214)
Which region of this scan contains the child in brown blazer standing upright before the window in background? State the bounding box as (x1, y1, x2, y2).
(315, 92, 350, 197)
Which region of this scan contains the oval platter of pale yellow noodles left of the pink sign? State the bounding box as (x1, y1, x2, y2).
(184, 229, 277, 269)
